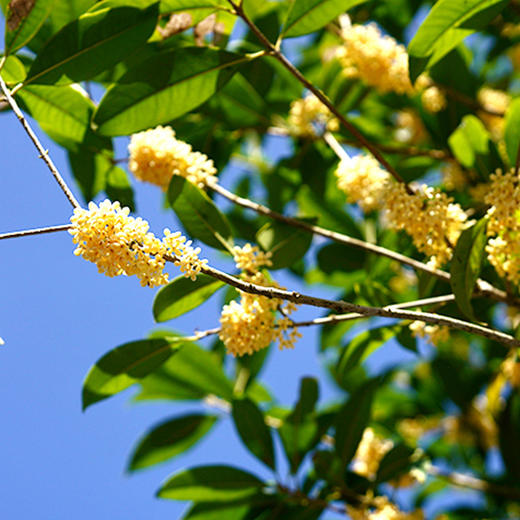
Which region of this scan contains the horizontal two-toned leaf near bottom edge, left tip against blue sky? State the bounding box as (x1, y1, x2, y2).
(157, 466, 264, 502)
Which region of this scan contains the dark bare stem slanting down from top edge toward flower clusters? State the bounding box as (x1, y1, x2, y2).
(228, 0, 413, 194)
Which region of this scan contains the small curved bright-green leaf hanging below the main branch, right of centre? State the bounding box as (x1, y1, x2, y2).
(337, 326, 400, 380)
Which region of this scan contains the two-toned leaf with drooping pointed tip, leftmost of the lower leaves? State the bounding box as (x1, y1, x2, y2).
(82, 338, 181, 410)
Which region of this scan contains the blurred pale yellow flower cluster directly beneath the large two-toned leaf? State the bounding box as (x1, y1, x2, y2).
(128, 126, 217, 190)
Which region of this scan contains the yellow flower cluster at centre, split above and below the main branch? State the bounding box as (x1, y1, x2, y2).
(219, 244, 301, 356)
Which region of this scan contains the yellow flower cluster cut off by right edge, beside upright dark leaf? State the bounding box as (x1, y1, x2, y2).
(484, 170, 520, 284)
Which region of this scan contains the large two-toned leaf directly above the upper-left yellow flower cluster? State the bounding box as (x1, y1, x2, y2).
(94, 47, 247, 136)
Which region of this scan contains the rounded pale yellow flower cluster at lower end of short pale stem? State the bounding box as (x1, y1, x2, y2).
(335, 154, 390, 212)
